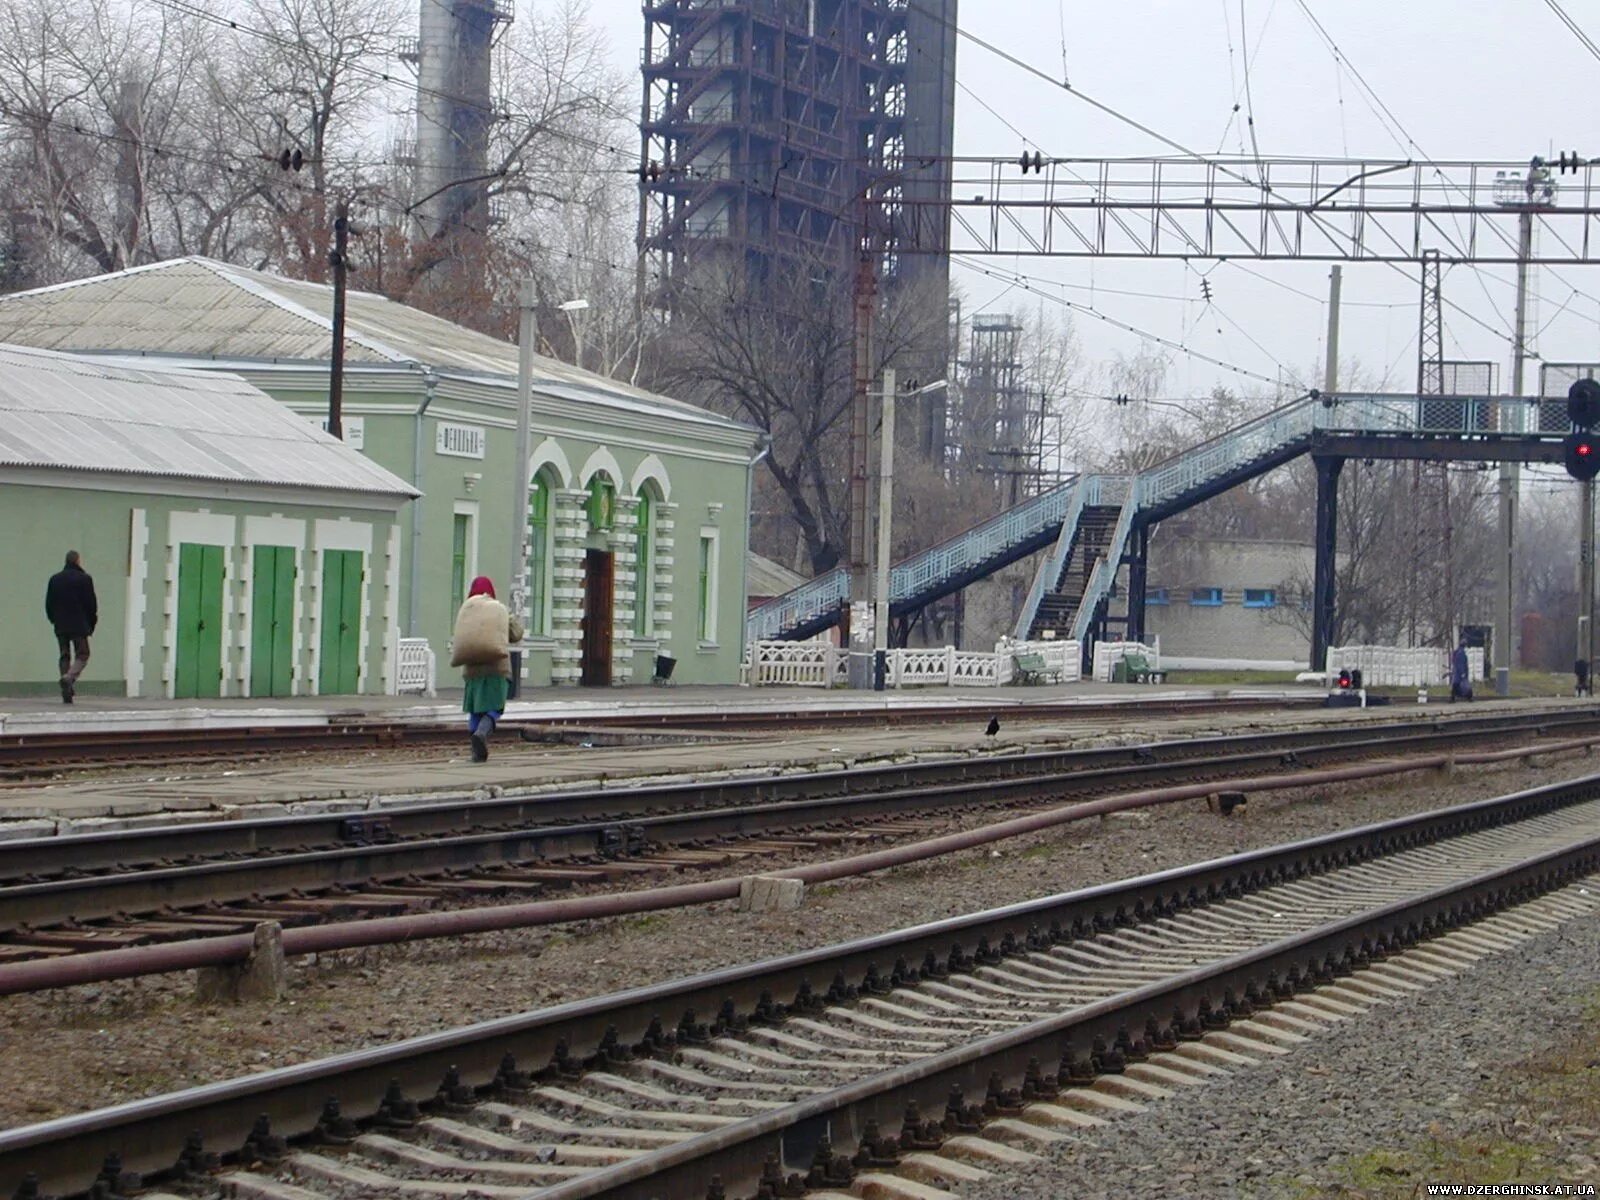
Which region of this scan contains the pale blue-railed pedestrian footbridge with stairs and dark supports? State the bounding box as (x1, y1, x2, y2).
(747, 392, 1571, 659)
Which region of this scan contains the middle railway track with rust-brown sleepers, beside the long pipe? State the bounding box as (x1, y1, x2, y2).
(0, 714, 1600, 966)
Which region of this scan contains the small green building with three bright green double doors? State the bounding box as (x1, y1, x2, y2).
(0, 344, 416, 698)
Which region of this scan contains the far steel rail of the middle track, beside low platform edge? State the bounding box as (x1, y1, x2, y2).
(0, 709, 1600, 883)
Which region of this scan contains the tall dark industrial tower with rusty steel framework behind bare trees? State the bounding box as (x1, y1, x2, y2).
(636, 0, 957, 331)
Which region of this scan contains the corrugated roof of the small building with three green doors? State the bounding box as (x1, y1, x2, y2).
(0, 344, 418, 496)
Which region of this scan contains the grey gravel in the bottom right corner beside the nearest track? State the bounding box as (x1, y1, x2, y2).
(965, 889, 1600, 1200)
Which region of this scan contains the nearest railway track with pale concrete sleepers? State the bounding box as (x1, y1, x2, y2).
(0, 776, 1600, 1200)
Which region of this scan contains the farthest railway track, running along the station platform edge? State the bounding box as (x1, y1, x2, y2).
(0, 696, 1320, 781)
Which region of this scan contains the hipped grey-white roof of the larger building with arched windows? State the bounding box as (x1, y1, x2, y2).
(0, 258, 754, 432)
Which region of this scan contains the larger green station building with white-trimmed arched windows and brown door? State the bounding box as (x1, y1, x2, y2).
(0, 258, 763, 696)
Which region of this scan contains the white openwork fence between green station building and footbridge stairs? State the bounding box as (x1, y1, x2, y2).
(744, 640, 1082, 688)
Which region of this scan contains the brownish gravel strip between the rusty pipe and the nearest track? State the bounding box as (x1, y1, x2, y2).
(0, 757, 1592, 1126)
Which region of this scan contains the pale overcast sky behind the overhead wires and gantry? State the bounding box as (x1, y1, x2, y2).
(576, 0, 1600, 422)
